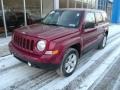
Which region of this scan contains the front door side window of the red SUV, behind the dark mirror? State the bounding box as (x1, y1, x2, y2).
(84, 12, 95, 29)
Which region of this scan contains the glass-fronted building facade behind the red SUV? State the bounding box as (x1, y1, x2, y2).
(0, 0, 111, 37)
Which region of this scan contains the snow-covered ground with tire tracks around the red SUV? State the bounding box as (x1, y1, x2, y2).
(0, 25, 120, 90)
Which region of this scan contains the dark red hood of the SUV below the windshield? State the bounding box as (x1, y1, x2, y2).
(16, 24, 77, 40)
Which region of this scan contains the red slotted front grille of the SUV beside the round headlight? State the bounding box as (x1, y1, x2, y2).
(14, 34, 35, 51)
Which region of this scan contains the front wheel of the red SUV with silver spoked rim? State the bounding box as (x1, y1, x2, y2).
(57, 48, 79, 77)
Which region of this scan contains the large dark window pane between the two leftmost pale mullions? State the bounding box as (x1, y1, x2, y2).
(2, 0, 24, 35)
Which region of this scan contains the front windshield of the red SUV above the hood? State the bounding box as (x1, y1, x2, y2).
(42, 10, 80, 28)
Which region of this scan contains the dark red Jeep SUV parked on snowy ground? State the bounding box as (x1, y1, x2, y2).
(9, 9, 109, 76)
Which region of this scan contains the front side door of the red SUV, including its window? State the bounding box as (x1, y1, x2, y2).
(82, 12, 98, 51)
